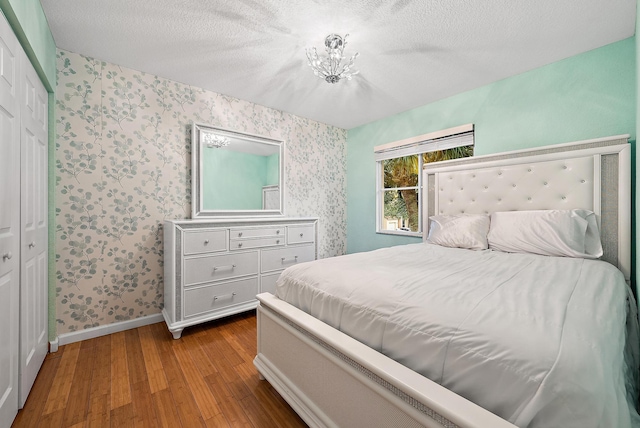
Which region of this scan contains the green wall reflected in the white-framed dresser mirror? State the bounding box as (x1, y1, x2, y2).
(202, 149, 278, 210)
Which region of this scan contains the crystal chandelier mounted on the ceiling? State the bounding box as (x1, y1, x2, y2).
(307, 34, 359, 83)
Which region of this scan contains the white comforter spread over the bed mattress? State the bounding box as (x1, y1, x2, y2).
(276, 244, 640, 428)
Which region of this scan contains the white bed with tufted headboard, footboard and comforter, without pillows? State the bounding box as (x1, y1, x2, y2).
(254, 136, 639, 428)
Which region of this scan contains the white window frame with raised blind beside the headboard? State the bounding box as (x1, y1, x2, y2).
(374, 124, 475, 237)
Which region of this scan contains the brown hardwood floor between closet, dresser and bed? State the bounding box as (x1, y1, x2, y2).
(13, 312, 306, 428)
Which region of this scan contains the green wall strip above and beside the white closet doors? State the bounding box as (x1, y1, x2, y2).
(0, 0, 56, 340)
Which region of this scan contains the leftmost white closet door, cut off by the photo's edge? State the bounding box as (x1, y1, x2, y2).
(0, 10, 20, 426)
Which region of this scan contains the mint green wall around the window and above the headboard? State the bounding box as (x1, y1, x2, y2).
(347, 37, 636, 253)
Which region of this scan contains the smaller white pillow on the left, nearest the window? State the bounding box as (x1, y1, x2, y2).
(427, 214, 489, 250)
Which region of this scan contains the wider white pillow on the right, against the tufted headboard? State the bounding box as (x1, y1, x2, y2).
(488, 210, 602, 259)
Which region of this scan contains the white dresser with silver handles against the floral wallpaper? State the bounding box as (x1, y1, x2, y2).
(162, 218, 318, 339)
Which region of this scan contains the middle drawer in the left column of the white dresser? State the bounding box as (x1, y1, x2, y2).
(184, 251, 258, 286)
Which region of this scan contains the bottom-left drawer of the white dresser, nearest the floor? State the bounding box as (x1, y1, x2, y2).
(184, 277, 258, 317)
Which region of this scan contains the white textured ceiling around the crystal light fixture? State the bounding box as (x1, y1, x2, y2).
(41, 0, 636, 129)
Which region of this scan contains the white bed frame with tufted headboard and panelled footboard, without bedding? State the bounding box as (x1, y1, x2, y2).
(254, 135, 631, 428)
